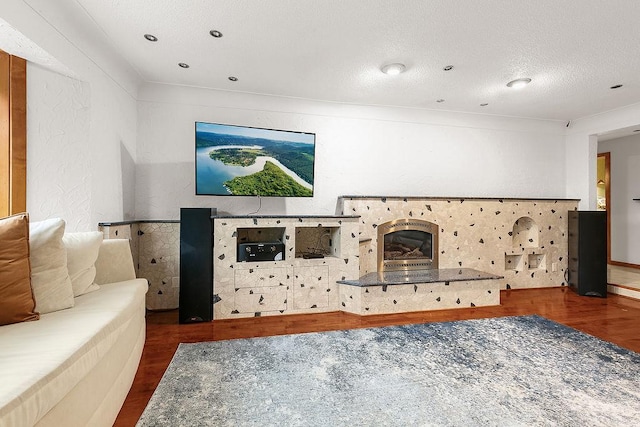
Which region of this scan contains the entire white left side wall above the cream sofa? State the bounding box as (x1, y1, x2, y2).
(2, 0, 137, 231)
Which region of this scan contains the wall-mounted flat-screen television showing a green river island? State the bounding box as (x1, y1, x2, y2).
(195, 122, 315, 197)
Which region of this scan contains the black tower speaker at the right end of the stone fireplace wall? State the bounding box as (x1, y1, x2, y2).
(569, 211, 607, 298)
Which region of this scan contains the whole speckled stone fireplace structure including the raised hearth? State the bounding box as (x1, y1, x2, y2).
(337, 196, 578, 315)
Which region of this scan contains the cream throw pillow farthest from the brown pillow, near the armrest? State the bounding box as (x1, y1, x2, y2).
(62, 231, 102, 297)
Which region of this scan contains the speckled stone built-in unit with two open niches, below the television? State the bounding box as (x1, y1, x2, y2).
(212, 216, 359, 320)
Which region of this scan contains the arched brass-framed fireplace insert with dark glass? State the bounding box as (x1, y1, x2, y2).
(378, 219, 438, 272)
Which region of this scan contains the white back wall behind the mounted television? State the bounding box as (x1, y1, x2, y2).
(136, 84, 566, 219)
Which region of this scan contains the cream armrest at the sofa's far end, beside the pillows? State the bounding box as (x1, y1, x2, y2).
(95, 239, 136, 285)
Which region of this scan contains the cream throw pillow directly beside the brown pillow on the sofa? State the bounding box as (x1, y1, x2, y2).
(29, 218, 74, 314)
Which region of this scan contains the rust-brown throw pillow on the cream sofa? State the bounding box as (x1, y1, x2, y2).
(0, 214, 40, 325)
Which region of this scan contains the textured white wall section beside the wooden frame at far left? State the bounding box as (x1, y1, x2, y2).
(27, 67, 95, 230)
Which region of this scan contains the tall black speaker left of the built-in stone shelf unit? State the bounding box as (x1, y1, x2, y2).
(178, 208, 217, 323)
